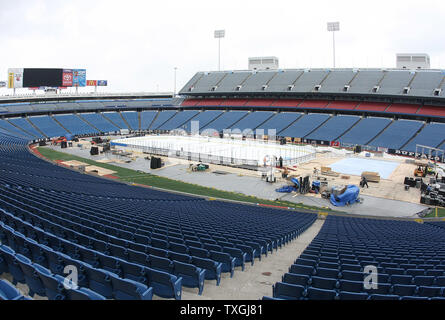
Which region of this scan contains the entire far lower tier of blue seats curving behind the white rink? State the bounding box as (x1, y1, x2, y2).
(0, 107, 445, 152)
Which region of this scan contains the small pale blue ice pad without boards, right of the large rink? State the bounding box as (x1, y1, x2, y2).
(331, 158, 400, 179)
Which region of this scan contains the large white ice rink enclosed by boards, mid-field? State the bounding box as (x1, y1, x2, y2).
(111, 136, 315, 166)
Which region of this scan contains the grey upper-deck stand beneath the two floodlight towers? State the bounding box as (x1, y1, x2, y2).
(180, 69, 445, 97)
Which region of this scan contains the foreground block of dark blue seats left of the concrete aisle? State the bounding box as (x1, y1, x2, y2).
(0, 131, 317, 300)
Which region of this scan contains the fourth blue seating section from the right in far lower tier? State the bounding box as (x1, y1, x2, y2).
(305, 116, 360, 141)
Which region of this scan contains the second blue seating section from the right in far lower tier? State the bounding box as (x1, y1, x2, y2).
(369, 120, 423, 150)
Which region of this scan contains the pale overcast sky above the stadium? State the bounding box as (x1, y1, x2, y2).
(0, 0, 445, 92)
